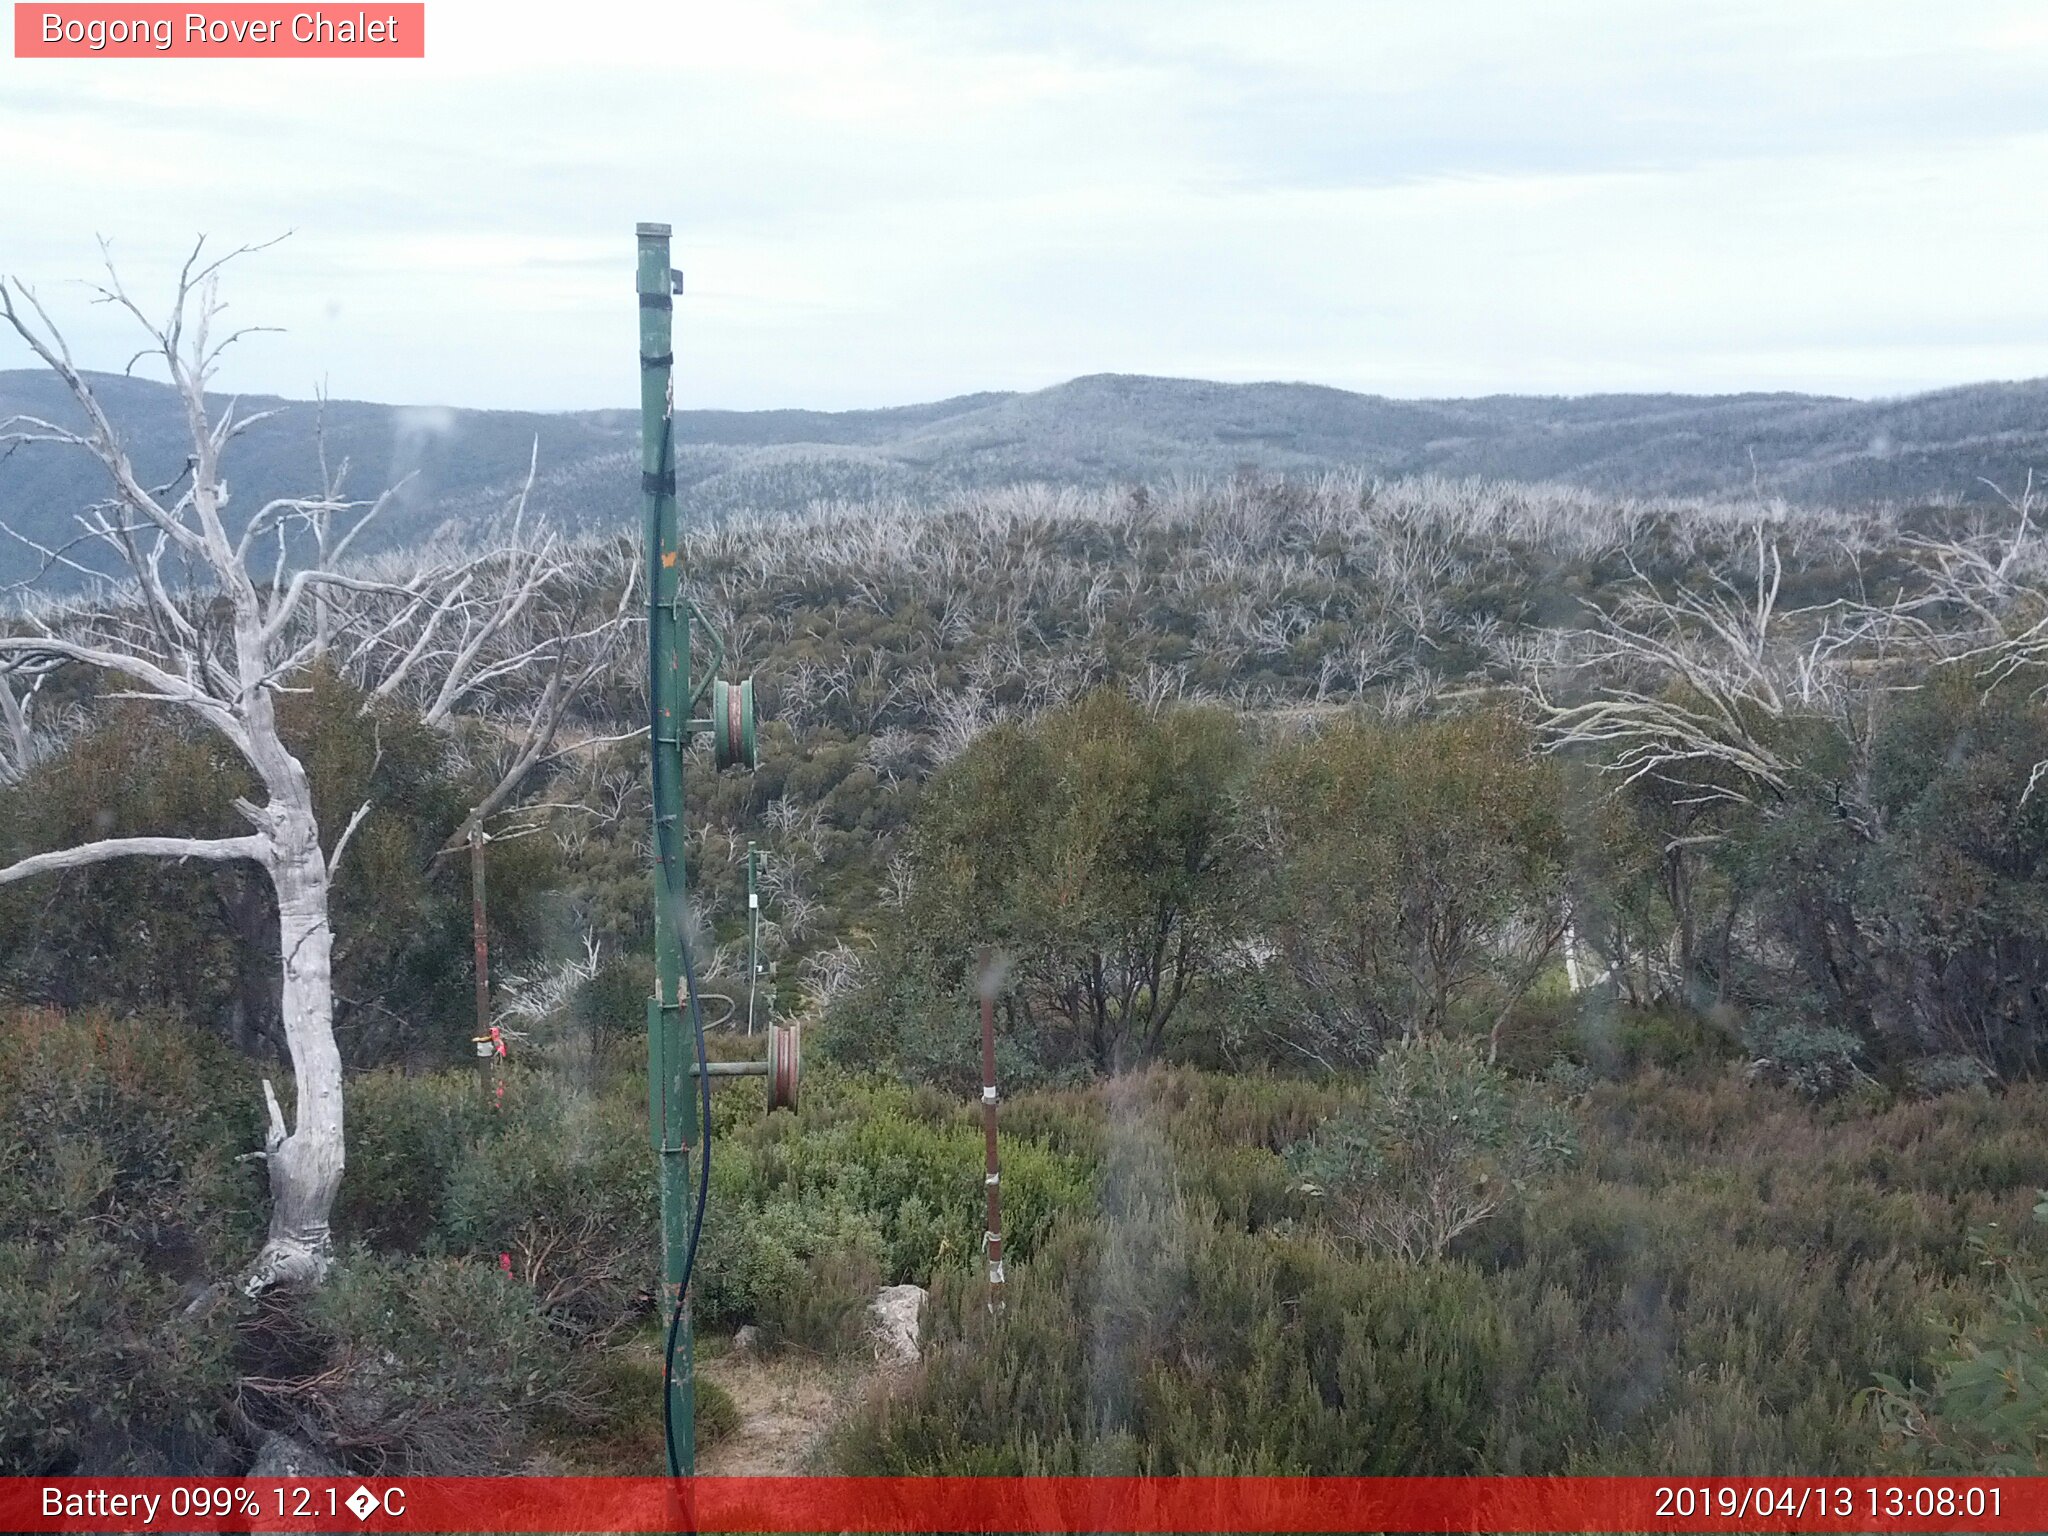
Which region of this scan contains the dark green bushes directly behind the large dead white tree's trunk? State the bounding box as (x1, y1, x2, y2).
(0, 668, 555, 1065)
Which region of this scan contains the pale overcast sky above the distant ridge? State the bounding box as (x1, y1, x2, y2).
(0, 0, 2048, 410)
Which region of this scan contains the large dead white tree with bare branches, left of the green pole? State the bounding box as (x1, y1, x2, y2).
(0, 242, 602, 1294)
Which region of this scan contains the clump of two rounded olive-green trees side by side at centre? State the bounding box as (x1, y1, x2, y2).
(825, 690, 1569, 1085)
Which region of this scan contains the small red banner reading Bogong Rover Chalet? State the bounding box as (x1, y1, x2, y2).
(14, 0, 426, 59)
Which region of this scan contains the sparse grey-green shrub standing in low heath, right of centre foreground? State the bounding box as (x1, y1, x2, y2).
(1288, 1038, 1573, 1262)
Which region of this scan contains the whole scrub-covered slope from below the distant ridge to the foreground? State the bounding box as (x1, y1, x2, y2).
(12, 475, 2048, 1473)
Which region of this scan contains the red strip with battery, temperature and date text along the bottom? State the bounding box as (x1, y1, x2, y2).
(0, 1477, 2048, 1532)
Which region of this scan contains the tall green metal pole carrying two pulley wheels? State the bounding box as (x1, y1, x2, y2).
(637, 223, 696, 1473)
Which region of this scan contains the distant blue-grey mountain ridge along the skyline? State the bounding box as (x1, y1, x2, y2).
(0, 371, 2048, 582)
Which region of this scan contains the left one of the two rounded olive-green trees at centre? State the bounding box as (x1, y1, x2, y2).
(831, 688, 1245, 1090)
